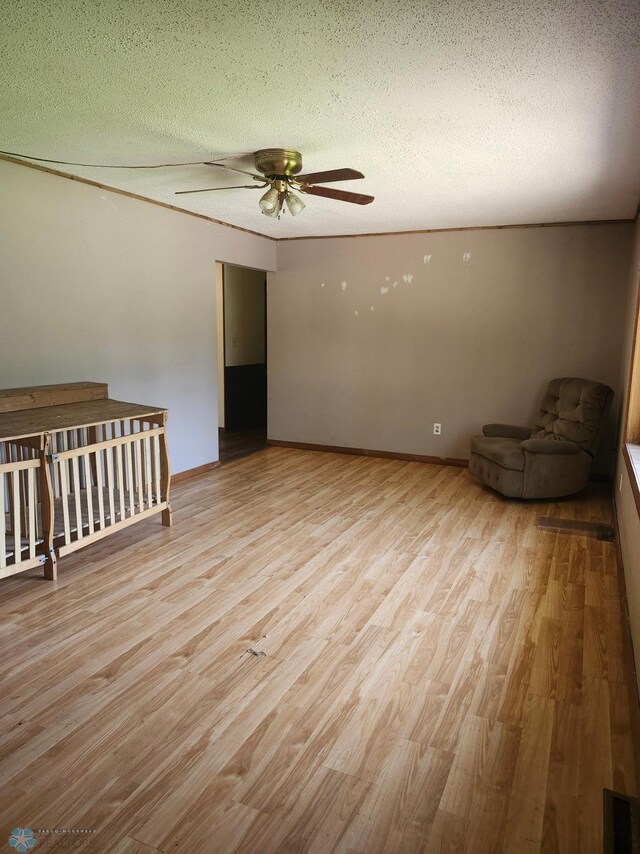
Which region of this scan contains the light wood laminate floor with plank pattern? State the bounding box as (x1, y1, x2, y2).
(0, 448, 638, 854)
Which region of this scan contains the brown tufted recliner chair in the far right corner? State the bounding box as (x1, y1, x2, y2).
(469, 377, 613, 498)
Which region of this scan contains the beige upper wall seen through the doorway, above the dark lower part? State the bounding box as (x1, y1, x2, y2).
(224, 264, 266, 367)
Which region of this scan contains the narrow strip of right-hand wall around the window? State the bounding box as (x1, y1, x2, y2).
(615, 220, 640, 700)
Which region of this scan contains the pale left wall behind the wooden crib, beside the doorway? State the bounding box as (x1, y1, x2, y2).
(0, 162, 275, 472)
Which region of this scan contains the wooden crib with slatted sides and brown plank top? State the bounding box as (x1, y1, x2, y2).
(0, 383, 171, 579)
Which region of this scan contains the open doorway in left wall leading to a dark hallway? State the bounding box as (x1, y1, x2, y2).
(216, 263, 267, 463)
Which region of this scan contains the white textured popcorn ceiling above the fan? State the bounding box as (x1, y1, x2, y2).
(0, 0, 640, 237)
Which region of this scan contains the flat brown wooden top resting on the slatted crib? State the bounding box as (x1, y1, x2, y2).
(0, 398, 166, 441)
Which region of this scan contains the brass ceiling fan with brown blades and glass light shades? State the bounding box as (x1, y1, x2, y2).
(176, 148, 373, 219)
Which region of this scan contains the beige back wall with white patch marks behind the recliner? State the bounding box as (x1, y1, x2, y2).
(268, 224, 633, 474)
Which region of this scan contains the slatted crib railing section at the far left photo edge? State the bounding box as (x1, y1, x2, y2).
(0, 438, 46, 578)
